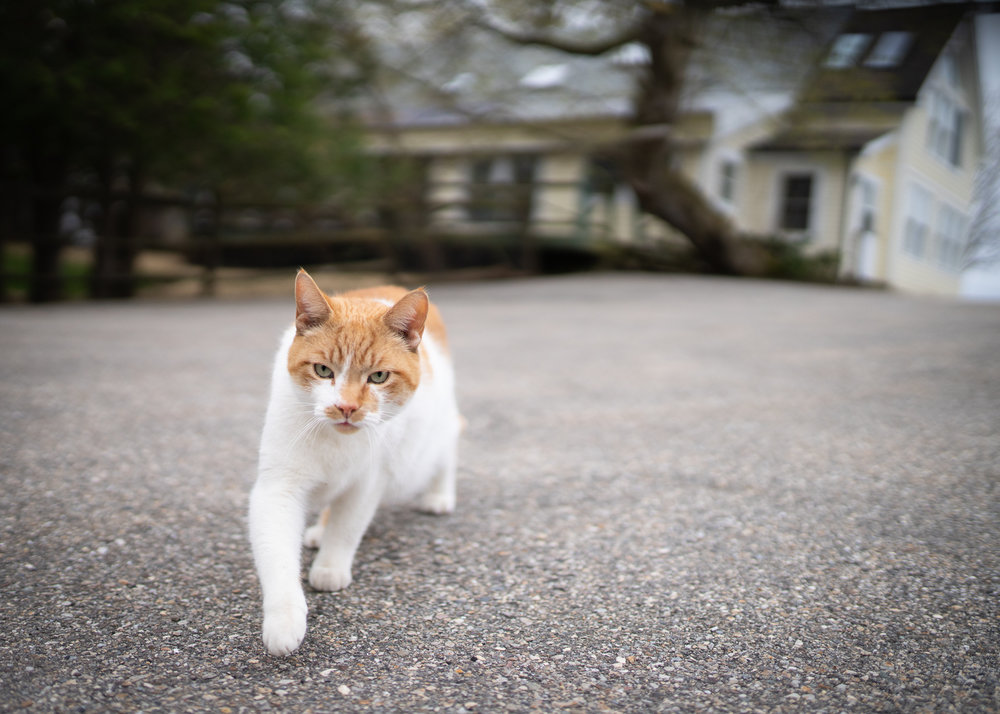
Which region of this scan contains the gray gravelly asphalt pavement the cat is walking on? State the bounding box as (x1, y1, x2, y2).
(0, 275, 1000, 712)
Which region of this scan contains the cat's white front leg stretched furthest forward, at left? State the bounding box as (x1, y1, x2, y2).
(249, 477, 307, 655)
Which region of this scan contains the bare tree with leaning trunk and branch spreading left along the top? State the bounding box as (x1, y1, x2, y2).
(356, 0, 818, 274)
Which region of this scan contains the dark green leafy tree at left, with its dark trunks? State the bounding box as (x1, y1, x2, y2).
(0, 0, 376, 301)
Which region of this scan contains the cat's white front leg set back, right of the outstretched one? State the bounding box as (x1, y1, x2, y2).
(309, 482, 382, 591)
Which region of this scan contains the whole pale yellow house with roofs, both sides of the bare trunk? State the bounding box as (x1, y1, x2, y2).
(362, 5, 983, 295)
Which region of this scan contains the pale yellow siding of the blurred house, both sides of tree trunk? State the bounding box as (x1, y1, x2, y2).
(369, 9, 982, 295)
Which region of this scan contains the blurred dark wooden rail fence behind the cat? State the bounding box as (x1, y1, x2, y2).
(0, 178, 610, 299)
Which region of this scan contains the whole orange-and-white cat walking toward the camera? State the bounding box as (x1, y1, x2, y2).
(249, 270, 462, 655)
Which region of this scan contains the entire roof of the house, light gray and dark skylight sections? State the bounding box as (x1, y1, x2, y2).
(369, 4, 967, 142)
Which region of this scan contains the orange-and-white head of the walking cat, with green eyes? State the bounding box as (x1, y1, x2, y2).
(288, 270, 428, 434)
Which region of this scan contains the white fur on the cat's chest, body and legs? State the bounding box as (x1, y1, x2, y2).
(249, 328, 460, 655)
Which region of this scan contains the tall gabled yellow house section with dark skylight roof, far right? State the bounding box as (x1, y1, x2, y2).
(740, 5, 983, 295)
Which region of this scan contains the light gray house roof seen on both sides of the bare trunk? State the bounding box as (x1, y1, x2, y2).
(368, 8, 849, 133)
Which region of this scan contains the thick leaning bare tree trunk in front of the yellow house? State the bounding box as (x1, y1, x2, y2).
(625, 4, 763, 274)
